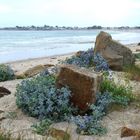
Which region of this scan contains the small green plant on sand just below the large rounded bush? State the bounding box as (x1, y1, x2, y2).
(32, 119, 53, 135)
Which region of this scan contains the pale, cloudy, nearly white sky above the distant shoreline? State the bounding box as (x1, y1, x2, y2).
(0, 0, 140, 27)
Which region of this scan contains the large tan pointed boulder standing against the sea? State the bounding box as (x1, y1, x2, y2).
(94, 31, 134, 70)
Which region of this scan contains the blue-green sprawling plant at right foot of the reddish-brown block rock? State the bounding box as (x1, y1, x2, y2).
(72, 92, 112, 135)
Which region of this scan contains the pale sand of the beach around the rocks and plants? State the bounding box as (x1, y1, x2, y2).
(0, 44, 140, 140)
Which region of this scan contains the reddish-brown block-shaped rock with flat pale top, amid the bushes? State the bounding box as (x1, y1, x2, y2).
(56, 65, 102, 112)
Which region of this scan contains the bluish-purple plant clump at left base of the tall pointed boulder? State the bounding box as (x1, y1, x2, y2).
(64, 48, 109, 71)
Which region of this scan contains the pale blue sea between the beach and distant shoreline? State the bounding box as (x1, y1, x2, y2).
(0, 30, 140, 63)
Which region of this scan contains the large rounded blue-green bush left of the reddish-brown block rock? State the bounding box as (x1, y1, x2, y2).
(16, 75, 74, 121)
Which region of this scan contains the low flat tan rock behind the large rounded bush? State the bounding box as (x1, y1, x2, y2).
(24, 65, 45, 77)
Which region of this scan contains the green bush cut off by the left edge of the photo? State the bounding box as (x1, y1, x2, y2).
(0, 64, 14, 82)
